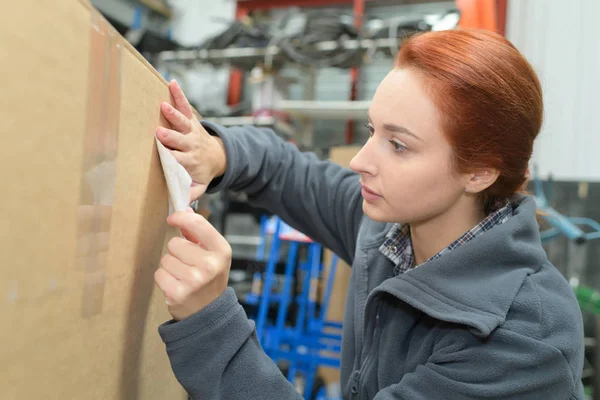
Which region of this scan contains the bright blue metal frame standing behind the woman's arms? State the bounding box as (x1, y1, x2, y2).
(247, 217, 342, 399)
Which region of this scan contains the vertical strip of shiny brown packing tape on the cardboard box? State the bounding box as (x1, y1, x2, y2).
(75, 11, 123, 318)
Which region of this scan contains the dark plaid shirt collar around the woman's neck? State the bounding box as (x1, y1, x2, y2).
(379, 203, 514, 275)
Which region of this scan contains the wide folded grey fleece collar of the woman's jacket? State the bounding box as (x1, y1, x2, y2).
(369, 197, 546, 336)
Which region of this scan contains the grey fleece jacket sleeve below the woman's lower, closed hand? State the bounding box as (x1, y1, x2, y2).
(159, 288, 301, 400)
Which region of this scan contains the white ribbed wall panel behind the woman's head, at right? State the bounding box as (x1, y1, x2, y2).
(507, 0, 600, 181)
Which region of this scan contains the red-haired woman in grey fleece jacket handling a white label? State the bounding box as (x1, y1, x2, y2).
(156, 30, 584, 400)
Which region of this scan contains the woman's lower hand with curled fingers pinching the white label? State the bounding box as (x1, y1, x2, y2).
(154, 208, 231, 321)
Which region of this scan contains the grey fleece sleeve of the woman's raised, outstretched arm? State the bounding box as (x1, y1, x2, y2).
(202, 121, 363, 263)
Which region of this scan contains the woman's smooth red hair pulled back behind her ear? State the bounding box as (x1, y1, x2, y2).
(396, 30, 543, 212)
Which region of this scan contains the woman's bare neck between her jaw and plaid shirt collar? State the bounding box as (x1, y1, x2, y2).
(410, 196, 486, 265)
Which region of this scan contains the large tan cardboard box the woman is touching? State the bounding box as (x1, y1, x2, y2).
(0, 0, 186, 400)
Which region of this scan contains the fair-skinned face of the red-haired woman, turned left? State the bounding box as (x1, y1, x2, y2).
(350, 69, 467, 223)
